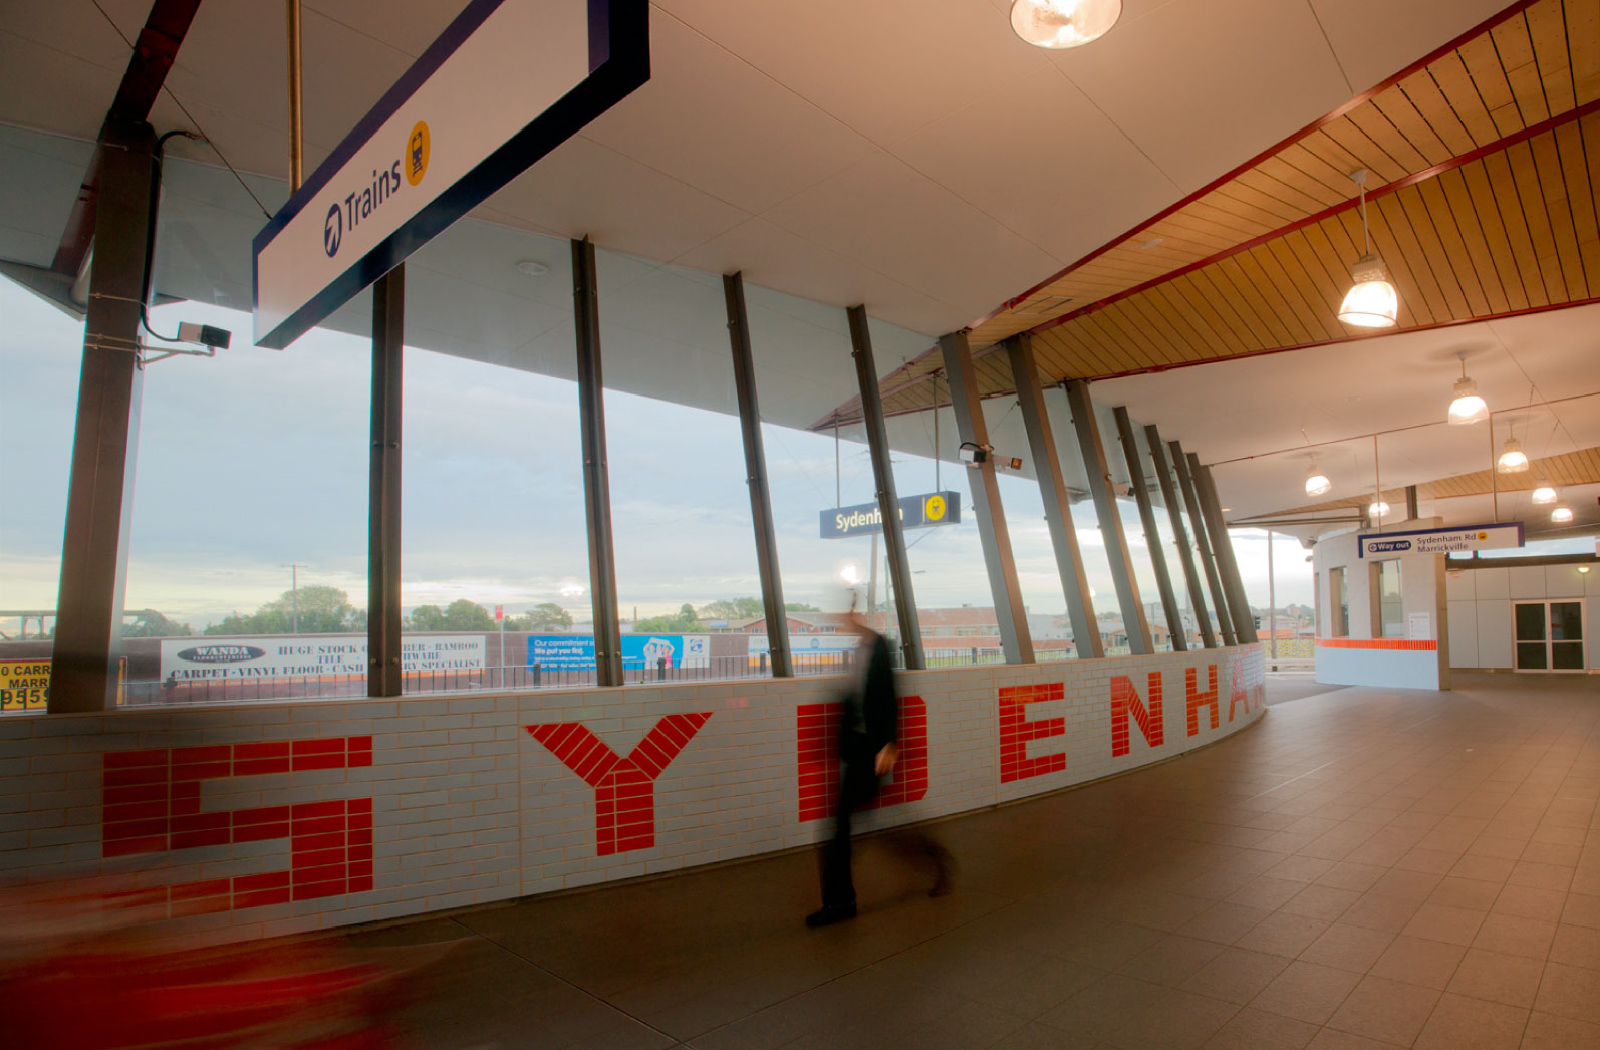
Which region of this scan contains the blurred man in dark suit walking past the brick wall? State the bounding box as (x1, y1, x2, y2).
(805, 603, 950, 927)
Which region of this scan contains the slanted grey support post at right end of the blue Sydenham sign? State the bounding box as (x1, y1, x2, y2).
(934, 331, 1034, 664)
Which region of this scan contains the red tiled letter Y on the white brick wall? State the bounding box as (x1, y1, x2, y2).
(525, 711, 712, 856)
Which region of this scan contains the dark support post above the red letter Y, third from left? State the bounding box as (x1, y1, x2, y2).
(573, 237, 622, 685)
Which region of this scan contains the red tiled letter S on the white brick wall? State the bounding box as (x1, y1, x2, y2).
(101, 736, 373, 916)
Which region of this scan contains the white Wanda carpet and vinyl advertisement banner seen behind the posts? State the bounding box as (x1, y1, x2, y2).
(162, 634, 488, 682)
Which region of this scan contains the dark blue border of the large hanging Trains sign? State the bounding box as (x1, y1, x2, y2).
(250, 0, 650, 351)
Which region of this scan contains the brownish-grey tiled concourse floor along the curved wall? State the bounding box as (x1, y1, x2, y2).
(350, 675, 1600, 1050)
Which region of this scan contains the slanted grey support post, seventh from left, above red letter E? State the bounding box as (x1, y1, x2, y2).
(1005, 331, 1106, 656)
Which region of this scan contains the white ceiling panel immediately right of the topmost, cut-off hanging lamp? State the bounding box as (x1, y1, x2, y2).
(1053, 0, 1352, 192)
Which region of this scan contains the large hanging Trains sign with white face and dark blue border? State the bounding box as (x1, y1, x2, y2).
(254, 0, 650, 349)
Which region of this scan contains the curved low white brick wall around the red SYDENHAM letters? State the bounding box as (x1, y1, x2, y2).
(0, 645, 1264, 940)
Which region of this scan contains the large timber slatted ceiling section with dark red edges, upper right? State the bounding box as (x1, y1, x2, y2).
(818, 0, 1600, 427)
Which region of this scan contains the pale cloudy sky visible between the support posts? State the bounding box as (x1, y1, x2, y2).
(0, 279, 1310, 629)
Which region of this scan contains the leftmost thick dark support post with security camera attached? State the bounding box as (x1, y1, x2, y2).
(50, 118, 155, 714)
